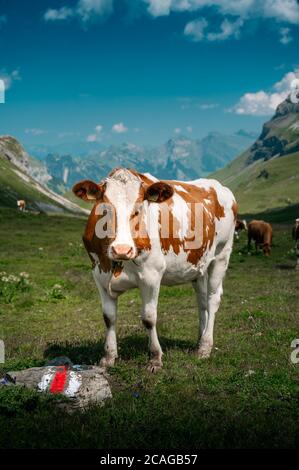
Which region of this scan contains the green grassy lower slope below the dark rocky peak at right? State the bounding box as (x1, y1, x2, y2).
(212, 152, 299, 214)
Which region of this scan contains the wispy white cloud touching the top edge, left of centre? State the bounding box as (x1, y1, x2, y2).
(44, 0, 113, 23)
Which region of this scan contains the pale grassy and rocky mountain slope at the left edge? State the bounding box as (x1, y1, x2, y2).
(0, 136, 88, 215)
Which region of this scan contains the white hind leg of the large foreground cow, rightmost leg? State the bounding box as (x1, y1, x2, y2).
(198, 241, 232, 358)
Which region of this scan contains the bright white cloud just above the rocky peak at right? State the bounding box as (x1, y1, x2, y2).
(234, 69, 299, 116)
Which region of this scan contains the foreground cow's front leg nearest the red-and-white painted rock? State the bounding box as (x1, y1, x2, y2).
(96, 282, 118, 367)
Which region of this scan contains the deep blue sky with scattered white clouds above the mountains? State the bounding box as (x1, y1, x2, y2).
(0, 0, 299, 145)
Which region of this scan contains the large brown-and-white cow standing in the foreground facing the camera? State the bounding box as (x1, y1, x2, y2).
(73, 168, 237, 372)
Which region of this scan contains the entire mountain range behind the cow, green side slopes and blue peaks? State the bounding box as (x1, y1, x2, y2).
(0, 98, 299, 216)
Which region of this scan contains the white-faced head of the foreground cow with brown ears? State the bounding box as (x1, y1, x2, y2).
(73, 168, 174, 260)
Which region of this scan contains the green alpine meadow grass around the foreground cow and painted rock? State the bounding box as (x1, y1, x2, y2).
(0, 209, 299, 449)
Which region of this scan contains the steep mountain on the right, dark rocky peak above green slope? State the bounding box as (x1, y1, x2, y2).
(211, 98, 299, 213)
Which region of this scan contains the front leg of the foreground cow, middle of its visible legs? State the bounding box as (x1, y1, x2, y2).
(140, 276, 163, 372)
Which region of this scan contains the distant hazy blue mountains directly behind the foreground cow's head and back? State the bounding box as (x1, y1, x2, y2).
(29, 131, 253, 194)
